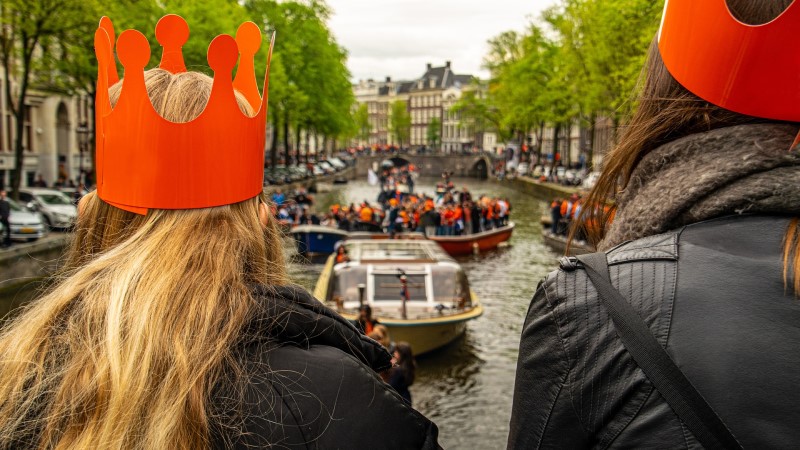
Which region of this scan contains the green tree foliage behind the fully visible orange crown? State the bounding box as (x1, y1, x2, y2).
(0, 0, 354, 195)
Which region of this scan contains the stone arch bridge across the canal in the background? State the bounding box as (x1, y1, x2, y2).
(356, 153, 494, 179)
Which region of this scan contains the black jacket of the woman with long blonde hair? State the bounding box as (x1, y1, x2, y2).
(212, 287, 439, 449)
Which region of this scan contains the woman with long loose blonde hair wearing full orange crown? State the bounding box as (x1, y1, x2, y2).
(0, 15, 438, 449)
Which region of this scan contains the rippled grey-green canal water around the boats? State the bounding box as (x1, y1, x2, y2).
(291, 179, 559, 449)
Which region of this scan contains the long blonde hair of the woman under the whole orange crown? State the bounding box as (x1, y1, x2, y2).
(0, 69, 288, 449)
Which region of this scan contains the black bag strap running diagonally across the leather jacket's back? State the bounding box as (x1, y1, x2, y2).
(577, 252, 742, 449)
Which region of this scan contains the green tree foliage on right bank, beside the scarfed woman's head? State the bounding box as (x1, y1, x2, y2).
(484, 0, 663, 156)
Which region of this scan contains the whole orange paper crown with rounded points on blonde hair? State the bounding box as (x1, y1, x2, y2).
(94, 15, 274, 214)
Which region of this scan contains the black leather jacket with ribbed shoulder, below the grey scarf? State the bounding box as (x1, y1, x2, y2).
(508, 216, 800, 449)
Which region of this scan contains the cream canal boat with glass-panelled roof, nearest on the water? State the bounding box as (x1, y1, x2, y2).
(314, 239, 483, 354)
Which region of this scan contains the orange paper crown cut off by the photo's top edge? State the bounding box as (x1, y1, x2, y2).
(658, 0, 800, 122)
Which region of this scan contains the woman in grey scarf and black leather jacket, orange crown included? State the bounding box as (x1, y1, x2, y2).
(508, 0, 800, 449)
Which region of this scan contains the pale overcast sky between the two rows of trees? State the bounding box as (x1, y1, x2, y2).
(327, 0, 556, 81)
